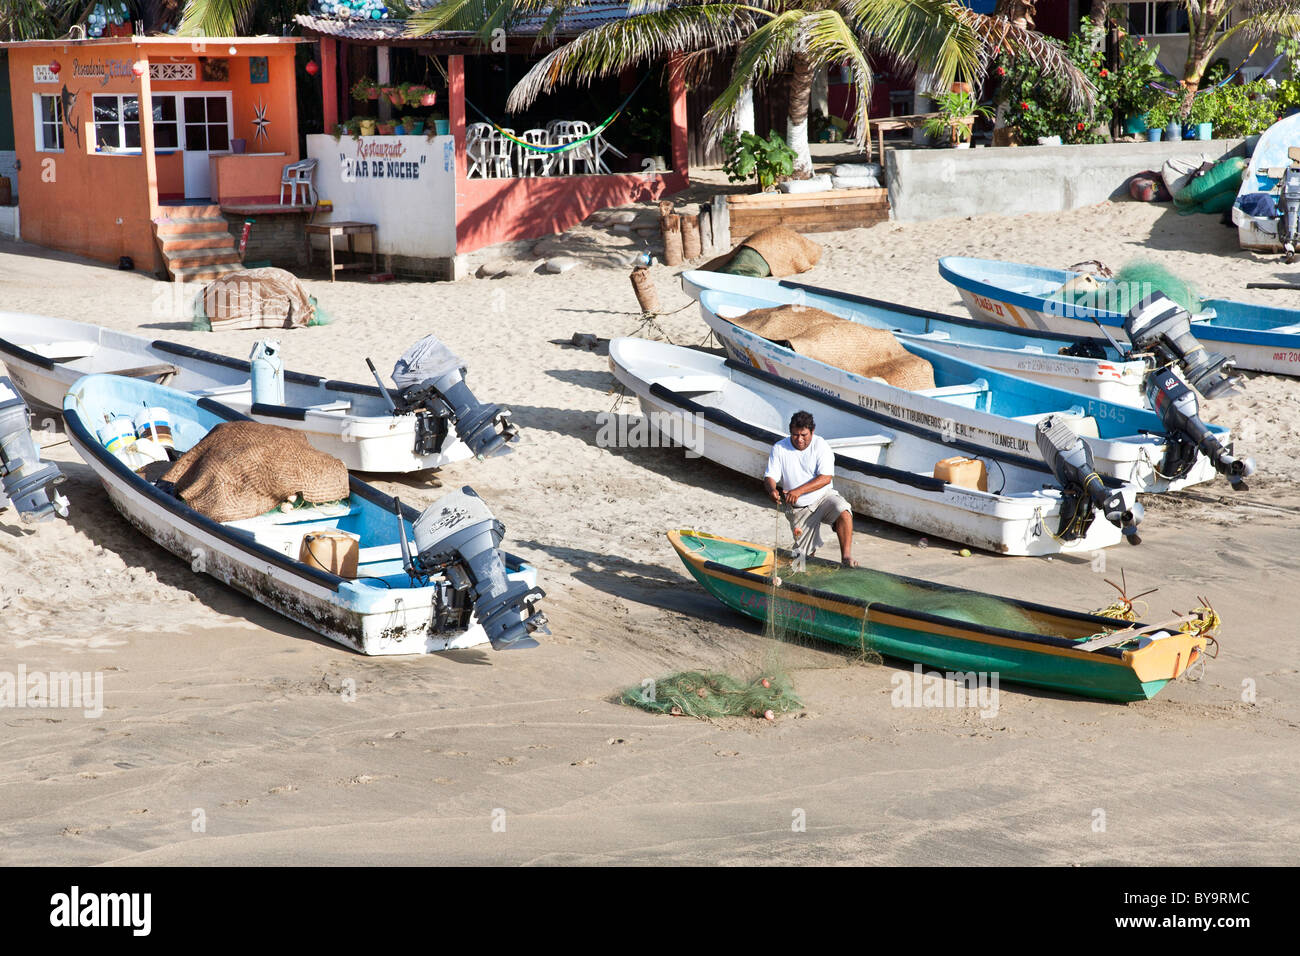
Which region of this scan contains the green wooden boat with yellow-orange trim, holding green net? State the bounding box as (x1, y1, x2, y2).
(668, 531, 1212, 701)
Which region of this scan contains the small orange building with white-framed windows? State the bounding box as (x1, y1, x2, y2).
(0, 36, 300, 271)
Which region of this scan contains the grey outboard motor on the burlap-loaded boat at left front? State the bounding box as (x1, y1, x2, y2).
(402, 486, 550, 650)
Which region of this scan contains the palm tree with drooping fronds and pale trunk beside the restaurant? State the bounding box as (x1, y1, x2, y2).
(411, 0, 1093, 176)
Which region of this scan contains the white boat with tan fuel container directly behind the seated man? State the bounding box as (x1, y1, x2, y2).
(610, 338, 1134, 554)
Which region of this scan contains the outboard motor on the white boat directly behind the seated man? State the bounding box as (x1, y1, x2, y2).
(1035, 415, 1144, 545)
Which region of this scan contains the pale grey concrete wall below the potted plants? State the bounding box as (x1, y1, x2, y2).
(885, 139, 1244, 222)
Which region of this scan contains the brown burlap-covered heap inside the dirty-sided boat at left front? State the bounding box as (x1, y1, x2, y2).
(163, 421, 350, 522)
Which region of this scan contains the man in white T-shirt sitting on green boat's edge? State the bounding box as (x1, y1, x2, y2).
(763, 411, 857, 567)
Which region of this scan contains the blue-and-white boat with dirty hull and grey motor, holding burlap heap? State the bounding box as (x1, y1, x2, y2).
(62, 375, 546, 654)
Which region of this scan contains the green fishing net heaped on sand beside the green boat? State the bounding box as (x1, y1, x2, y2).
(619, 671, 803, 719)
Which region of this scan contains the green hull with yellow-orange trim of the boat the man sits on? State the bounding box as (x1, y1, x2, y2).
(668, 531, 1205, 701)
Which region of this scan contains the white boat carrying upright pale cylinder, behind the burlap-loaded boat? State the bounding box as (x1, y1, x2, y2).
(0, 312, 472, 473)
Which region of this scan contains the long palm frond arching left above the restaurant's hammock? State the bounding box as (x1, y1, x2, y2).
(506, 3, 754, 113)
